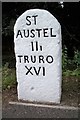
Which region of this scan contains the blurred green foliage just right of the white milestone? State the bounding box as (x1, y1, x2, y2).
(62, 47, 80, 77)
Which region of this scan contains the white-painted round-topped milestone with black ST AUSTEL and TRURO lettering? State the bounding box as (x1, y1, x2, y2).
(14, 9, 61, 103)
